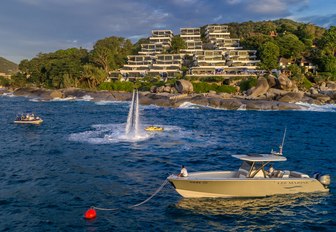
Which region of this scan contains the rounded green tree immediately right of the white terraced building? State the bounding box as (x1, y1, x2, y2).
(260, 42, 280, 70)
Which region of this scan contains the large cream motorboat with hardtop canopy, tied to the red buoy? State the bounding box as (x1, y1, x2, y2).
(168, 134, 330, 198)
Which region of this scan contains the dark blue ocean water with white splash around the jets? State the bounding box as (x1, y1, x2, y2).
(0, 96, 336, 231)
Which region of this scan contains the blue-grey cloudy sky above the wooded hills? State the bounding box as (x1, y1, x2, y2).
(0, 0, 336, 63)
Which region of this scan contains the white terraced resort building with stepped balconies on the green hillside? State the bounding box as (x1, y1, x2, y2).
(119, 25, 260, 78)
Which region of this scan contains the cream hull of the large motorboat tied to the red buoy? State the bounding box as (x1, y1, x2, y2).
(168, 172, 329, 198)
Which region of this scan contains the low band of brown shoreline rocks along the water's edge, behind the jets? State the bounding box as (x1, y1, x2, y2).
(0, 88, 312, 110)
